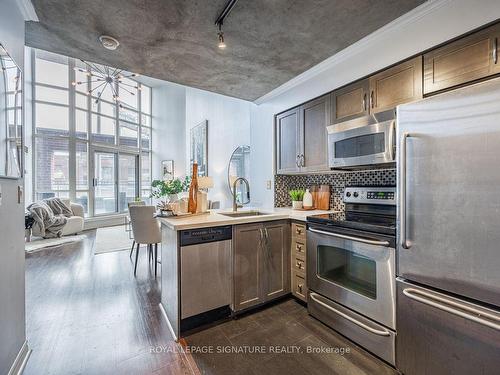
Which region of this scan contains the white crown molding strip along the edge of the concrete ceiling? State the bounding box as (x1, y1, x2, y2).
(254, 0, 452, 104)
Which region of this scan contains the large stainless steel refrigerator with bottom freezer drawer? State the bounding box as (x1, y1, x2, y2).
(396, 79, 500, 375)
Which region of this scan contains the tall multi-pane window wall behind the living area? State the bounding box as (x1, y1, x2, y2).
(32, 50, 152, 216)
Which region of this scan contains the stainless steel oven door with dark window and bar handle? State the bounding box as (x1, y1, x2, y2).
(307, 225, 396, 329)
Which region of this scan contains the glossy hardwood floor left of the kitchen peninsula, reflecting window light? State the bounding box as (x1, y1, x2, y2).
(25, 231, 192, 375)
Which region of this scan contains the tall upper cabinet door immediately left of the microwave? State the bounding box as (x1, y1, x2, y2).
(299, 95, 330, 172)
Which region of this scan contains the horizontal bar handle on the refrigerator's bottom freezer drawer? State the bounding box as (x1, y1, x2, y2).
(403, 288, 500, 331)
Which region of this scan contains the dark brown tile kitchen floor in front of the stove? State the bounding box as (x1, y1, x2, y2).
(186, 299, 398, 375)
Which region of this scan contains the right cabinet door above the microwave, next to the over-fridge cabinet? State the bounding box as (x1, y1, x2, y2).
(370, 56, 422, 113)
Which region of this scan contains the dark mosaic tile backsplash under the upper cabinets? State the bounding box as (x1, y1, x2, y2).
(274, 169, 396, 211)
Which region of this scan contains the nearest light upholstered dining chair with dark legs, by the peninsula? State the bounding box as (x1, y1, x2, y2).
(129, 205, 161, 278)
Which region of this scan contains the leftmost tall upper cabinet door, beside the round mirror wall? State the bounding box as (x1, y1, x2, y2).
(275, 108, 300, 173)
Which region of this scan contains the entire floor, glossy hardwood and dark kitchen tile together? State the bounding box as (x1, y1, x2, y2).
(25, 232, 395, 375)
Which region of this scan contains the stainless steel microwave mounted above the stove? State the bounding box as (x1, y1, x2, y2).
(327, 112, 396, 169)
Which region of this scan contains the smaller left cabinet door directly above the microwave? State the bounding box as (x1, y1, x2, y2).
(330, 79, 369, 124)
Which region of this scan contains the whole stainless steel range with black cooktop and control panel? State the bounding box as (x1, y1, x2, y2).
(307, 186, 396, 365)
